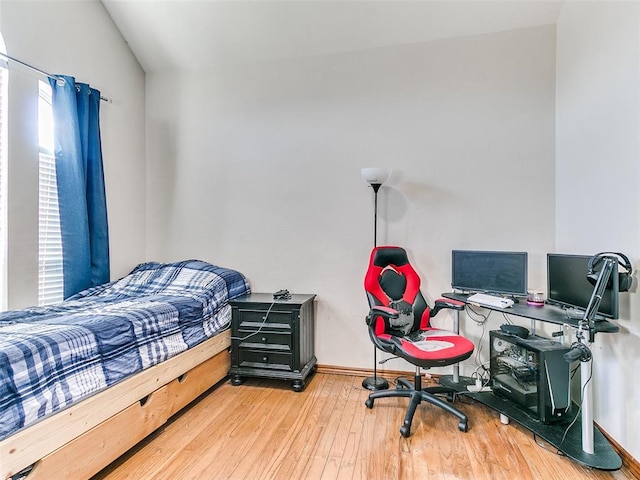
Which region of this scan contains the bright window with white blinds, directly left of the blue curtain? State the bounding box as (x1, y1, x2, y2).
(38, 81, 64, 305)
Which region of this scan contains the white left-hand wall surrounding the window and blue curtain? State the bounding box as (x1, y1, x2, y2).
(0, 0, 146, 308)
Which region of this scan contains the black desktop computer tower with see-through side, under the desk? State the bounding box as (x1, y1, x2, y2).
(489, 331, 571, 423)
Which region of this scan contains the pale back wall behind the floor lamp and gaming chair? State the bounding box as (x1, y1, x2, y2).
(147, 26, 555, 370)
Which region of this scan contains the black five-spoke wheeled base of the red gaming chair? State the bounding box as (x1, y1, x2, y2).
(364, 369, 469, 438)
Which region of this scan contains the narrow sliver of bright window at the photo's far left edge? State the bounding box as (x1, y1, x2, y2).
(0, 34, 9, 310)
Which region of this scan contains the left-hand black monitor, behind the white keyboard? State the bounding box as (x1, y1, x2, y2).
(451, 250, 527, 296)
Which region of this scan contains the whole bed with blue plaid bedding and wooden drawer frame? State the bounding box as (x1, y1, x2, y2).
(0, 260, 250, 480)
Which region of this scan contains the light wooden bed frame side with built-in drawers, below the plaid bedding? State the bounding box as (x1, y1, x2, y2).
(0, 330, 231, 480)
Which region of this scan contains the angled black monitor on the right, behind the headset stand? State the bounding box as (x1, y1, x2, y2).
(547, 253, 618, 319)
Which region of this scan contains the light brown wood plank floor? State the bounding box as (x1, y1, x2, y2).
(93, 373, 634, 480)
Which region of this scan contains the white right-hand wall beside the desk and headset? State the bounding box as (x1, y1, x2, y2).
(556, 2, 640, 458)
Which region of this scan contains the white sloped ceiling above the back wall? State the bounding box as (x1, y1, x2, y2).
(102, 0, 563, 72)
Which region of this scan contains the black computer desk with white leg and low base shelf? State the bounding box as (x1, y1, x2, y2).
(440, 293, 622, 470)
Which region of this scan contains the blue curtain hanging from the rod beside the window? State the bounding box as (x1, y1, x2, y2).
(50, 76, 110, 298)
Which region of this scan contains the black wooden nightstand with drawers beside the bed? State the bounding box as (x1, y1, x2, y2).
(229, 293, 317, 392)
